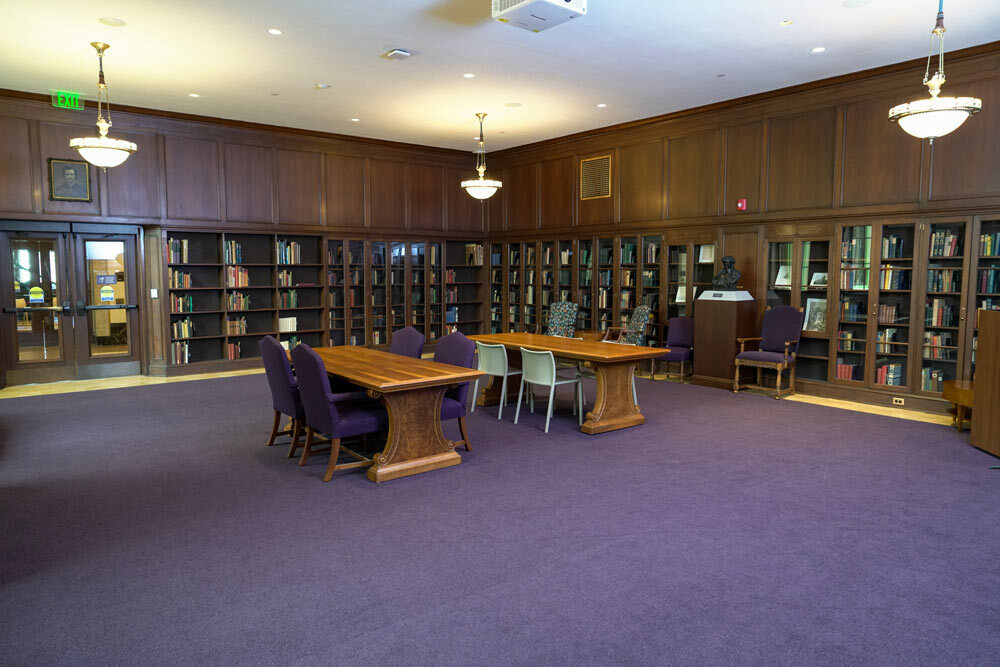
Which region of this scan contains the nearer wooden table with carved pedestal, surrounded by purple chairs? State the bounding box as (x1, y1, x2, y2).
(313, 345, 483, 482)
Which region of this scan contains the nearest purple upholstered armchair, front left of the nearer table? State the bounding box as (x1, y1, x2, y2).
(292, 344, 389, 482)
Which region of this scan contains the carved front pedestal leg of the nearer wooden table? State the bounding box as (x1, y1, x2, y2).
(368, 385, 462, 482)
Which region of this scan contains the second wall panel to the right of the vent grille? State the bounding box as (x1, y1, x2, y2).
(667, 130, 722, 218)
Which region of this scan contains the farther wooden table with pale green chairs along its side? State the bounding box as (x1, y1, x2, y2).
(469, 333, 670, 435)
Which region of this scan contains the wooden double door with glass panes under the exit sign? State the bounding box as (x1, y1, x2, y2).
(0, 231, 140, 384)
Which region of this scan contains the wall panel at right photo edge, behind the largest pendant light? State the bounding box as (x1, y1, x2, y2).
(928, 77, 1000, 199)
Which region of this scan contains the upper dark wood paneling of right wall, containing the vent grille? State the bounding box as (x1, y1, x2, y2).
(488, 43, 1000, 237)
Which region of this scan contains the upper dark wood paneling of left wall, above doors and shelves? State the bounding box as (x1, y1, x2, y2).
(0, 94, 486, 238)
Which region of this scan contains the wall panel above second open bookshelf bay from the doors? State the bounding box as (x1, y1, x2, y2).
(224, 144, 274, 222)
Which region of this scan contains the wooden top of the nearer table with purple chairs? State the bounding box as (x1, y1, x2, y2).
(313, 345, 484, 394)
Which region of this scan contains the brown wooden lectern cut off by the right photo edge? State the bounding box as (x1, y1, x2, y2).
(969, 310, 1000, 456)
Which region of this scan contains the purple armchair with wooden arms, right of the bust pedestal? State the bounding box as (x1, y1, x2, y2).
(733, 306, 805, 398)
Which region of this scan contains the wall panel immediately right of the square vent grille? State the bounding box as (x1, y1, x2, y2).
(618, 140, 664, 222)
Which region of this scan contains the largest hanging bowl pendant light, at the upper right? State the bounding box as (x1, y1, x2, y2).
(889, 0, 983, 143)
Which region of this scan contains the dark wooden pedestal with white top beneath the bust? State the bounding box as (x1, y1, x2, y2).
(691, 289, 757, 389)
